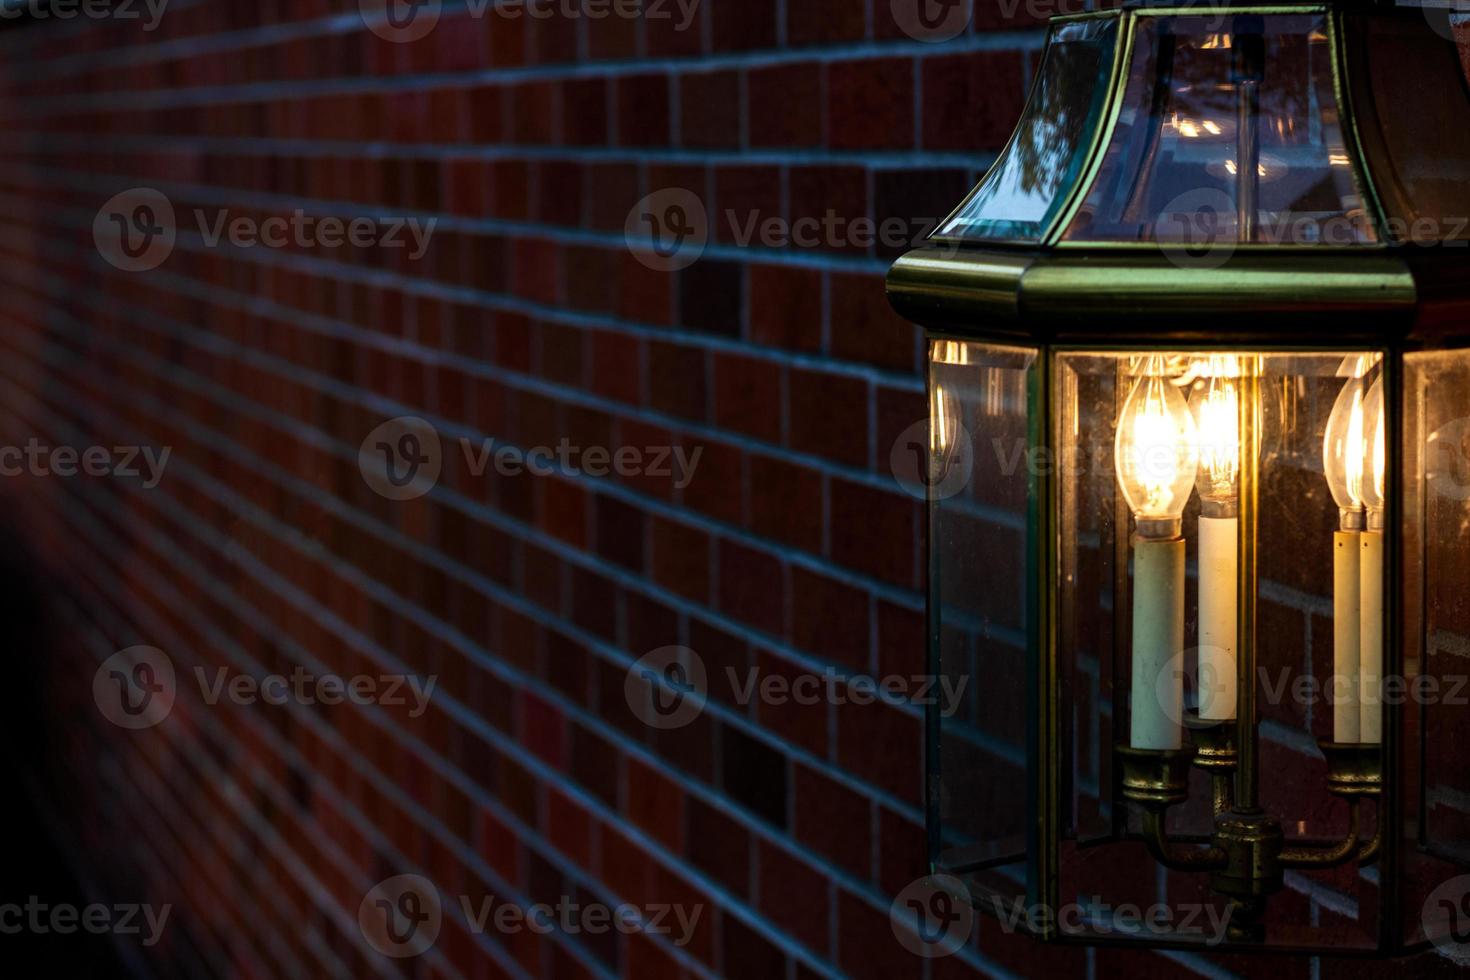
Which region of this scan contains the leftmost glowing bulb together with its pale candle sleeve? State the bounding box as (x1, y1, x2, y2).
(1113, 354, 1200, 749)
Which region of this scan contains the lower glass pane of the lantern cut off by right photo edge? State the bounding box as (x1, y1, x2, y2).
(1395, 351, 1470, 946)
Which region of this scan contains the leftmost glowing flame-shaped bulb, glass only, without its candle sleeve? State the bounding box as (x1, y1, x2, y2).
(1113, 354, 1200, 538)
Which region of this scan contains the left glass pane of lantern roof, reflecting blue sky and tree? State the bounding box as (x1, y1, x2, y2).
(935, 19, 1117, 242)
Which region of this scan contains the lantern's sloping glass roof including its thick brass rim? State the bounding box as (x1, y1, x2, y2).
(888, 0, 1470, 345)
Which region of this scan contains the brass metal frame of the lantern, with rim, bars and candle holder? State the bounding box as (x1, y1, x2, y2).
(888, 0, 1470, 955)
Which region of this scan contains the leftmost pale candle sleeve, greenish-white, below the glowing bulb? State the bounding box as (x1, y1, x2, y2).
(1129, 538, 1185, 749)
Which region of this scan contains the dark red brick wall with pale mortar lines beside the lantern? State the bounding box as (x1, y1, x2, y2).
(0, 0, 1458, 980)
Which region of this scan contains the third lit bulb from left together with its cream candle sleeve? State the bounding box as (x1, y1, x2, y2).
(1322, 354, 1382, 742)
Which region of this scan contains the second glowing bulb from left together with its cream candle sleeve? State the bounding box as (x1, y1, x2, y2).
(1189, 354, 1241, 721)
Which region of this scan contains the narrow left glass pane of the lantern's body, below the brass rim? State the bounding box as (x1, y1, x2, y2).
(926, 341, 1039, 905)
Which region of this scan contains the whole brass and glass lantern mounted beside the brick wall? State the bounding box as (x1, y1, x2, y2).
(888, 0, 1470, 954)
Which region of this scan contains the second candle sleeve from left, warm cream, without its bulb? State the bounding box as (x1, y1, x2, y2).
(1195, 517, 1241, 721)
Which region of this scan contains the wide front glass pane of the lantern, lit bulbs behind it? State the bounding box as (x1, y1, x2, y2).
(1054, 351, 1382, 949)
